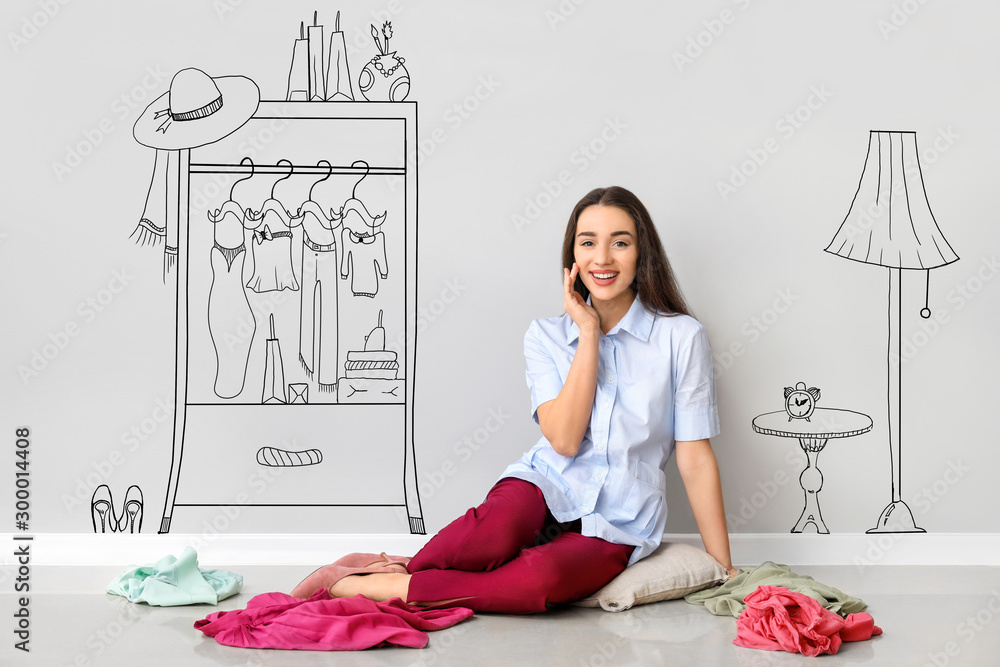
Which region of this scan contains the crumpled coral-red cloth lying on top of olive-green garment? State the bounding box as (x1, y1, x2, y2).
(733, 586, 882, 656)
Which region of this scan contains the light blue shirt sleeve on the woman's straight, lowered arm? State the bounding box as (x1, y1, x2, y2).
(674, 324, 719, 441)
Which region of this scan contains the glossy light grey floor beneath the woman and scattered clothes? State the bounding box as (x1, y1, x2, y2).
(0, 565, 1000, 667)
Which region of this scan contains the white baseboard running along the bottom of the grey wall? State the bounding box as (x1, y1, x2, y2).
(0, 533, 1000, 567)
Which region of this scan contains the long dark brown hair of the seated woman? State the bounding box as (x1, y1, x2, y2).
(563, 186, 691, 316)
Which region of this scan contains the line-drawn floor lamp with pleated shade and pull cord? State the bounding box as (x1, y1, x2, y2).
(826, 130, 958, 533)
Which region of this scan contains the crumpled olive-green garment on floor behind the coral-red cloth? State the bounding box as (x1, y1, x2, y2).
(684, 561, 868, 617)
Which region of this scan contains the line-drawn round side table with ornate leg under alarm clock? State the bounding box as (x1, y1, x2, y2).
(753, 408, 872, 535)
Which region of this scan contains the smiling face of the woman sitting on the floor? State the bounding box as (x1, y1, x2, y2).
(573, 205, 639, 303)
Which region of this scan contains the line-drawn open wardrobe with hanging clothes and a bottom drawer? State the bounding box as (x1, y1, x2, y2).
(159, 101, 425, 534)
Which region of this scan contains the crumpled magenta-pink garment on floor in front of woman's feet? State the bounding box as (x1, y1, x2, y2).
(194, 589, 473, 651)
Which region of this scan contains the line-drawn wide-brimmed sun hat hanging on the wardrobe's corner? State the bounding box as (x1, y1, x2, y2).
(132, 67, 260, 150)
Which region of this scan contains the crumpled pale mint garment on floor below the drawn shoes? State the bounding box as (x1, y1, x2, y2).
(105, 547, 243, 607)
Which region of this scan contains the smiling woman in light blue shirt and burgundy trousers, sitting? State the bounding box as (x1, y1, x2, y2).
(296, 187, 736, 613)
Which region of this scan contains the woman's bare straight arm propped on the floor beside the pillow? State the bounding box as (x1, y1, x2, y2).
(676, 438, 736, 577)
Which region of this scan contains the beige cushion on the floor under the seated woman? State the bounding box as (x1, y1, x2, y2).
(572, 542, 728, 611)
